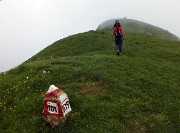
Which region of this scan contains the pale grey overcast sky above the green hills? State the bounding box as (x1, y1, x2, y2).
(0, 0, 180, 72)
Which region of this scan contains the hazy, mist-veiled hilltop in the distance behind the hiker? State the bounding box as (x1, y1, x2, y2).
(97, 18, 179, 40)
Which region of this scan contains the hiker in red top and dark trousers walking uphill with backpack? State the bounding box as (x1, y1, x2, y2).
(112, 20, 123, 55)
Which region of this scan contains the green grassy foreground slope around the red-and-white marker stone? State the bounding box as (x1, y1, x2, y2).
(0, 31, 180, 133)
